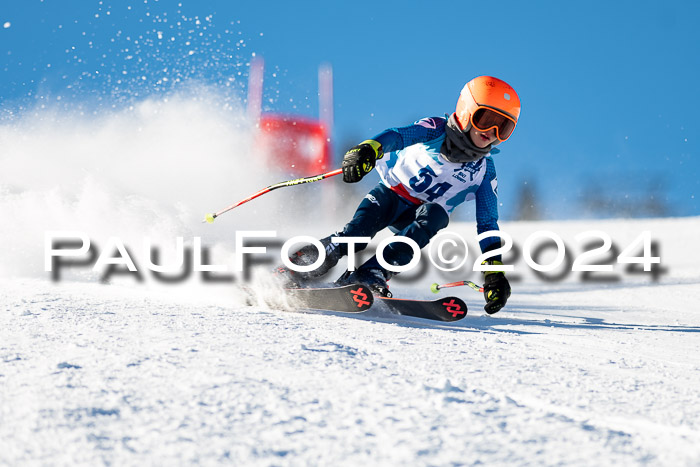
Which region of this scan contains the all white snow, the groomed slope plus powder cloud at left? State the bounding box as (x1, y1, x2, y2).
(0, 93, 700, 466)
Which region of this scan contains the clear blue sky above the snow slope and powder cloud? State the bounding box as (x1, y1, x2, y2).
(0, 0, 700, 218)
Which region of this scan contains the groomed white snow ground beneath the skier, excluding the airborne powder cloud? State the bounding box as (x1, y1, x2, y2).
(0, 218, 700, 466)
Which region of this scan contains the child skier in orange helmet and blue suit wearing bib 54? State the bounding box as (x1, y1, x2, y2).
(277, 76, 520, 314)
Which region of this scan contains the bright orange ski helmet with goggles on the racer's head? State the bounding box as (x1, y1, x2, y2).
(455, 76, 520, 142)
